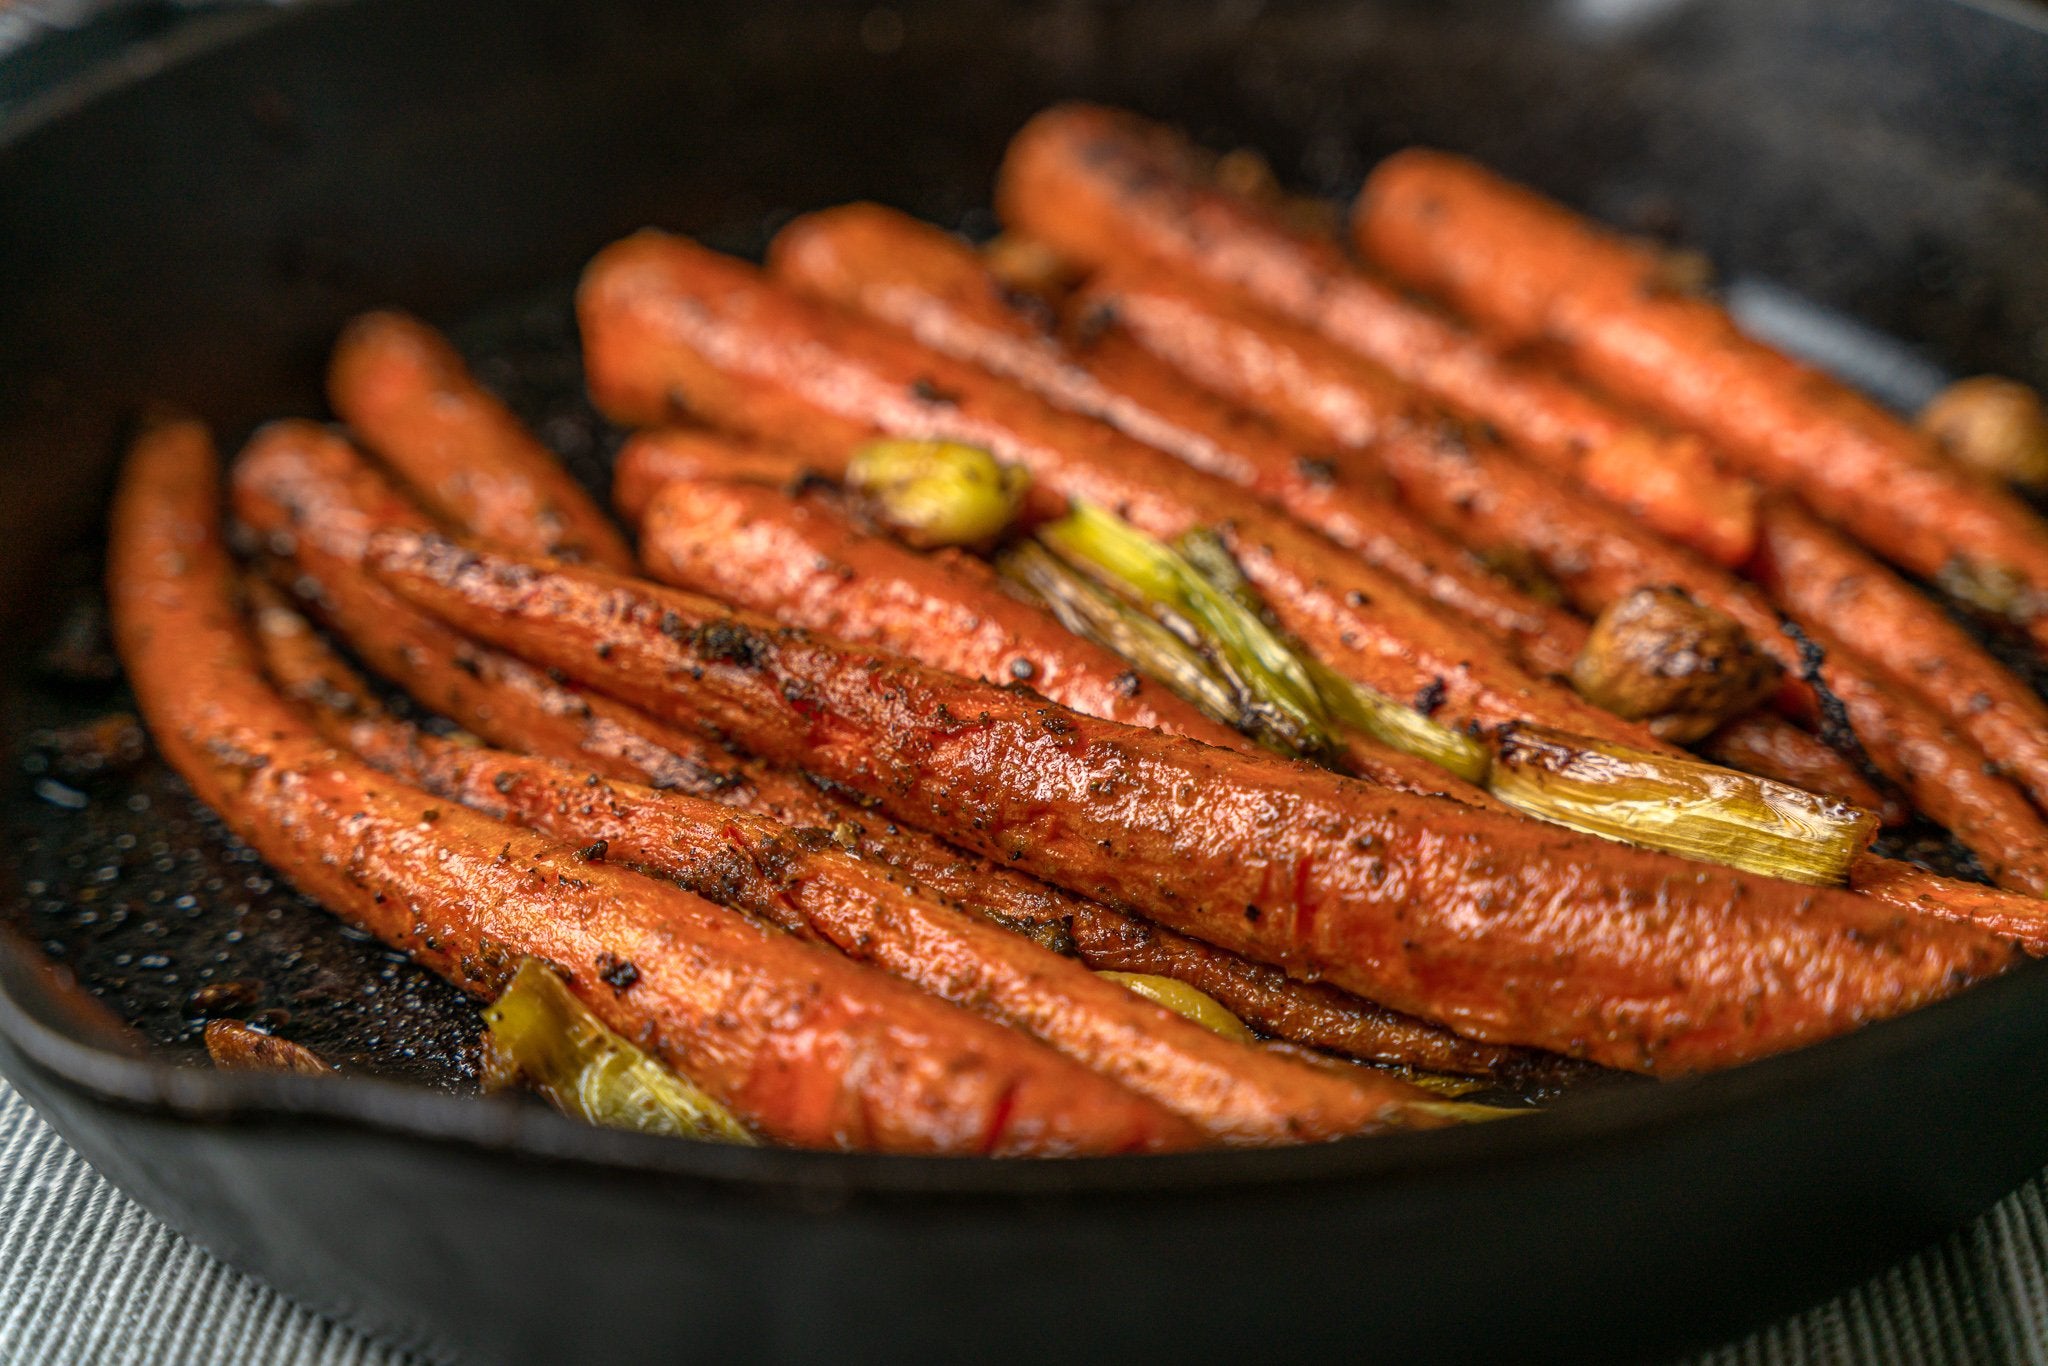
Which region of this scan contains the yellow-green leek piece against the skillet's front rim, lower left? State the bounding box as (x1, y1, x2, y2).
(483, 958, 756, 1145)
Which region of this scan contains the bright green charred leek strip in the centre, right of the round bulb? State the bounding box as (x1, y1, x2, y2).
(1038, 502, 1333, 754)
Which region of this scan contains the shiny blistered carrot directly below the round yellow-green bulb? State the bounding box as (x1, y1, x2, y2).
(641, 481, 1251, 750)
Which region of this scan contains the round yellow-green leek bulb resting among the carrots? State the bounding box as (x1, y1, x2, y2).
(846, 440, 1030, 547)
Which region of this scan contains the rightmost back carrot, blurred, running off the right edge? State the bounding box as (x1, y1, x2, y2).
(1356, 150, 2048, 643)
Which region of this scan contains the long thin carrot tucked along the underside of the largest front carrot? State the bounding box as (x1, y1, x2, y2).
(236, 440, 1548, 1077)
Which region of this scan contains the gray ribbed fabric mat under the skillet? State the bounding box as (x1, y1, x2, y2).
(0, 1081, 2048, 1366)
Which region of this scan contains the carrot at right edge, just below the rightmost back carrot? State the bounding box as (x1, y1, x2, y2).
(1749, 498, 2048, 811)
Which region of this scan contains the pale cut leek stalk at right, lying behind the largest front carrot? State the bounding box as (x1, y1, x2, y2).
(1487, 723, 1878, 887)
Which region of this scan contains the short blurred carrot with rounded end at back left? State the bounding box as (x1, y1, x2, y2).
(328, 313, 633, 571)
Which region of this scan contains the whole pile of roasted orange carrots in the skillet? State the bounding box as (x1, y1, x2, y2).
(109, 106, 2048, 1155)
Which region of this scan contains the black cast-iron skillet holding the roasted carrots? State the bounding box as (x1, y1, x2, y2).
(0, 0, 2048, 1362)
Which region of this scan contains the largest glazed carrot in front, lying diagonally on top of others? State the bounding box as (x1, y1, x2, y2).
(371, 532, 2011, 1073)
